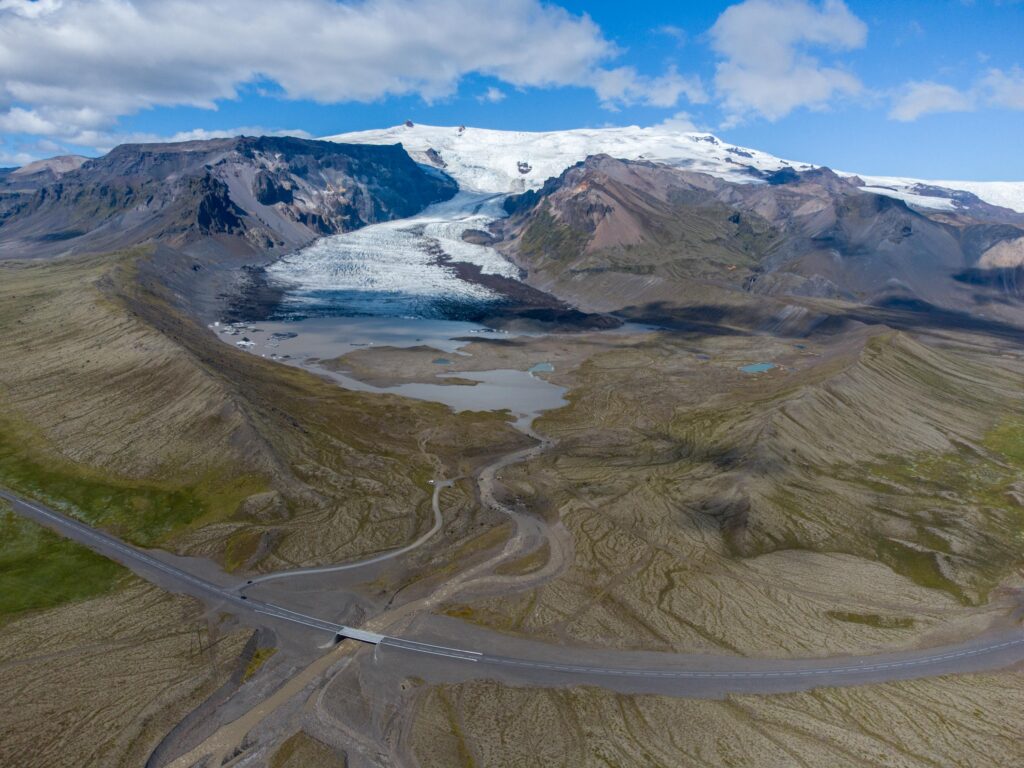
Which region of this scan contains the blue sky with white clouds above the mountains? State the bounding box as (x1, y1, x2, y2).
(0, 0, 1024, 180)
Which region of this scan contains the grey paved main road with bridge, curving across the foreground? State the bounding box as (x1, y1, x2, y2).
(0, 490, 1024, 695)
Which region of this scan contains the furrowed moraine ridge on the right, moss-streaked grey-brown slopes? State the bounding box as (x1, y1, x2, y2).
(647, 334, 1024, 603)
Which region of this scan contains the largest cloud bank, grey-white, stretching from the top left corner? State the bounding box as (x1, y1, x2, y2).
(0, 0, 699, 140)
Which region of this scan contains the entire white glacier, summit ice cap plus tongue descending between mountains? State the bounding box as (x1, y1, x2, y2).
(268, 124, 1024, 318)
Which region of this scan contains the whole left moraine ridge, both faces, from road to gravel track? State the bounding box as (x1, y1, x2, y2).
(0, 251, 518, 567)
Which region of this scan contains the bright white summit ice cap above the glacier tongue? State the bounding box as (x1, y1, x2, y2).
(325, 123, 1024, 213)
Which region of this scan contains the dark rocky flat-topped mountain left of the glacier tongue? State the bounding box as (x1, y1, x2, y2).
(0, 137, 456, 258)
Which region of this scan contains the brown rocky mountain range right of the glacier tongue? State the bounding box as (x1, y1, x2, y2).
(496, 156, 1024, 325)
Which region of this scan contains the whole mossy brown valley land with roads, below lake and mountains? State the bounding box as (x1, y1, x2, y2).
(0, 199, 1024, 768)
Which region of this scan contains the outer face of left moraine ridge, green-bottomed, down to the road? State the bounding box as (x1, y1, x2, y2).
(0, 250, 268, 545)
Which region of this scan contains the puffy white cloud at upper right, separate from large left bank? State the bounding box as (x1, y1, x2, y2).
(710, 0, 867, 125)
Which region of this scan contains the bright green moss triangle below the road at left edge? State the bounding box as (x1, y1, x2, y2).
(0, 509, 127, 624)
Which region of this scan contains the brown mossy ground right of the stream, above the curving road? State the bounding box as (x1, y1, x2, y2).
(450, 331, 1024, 655)
